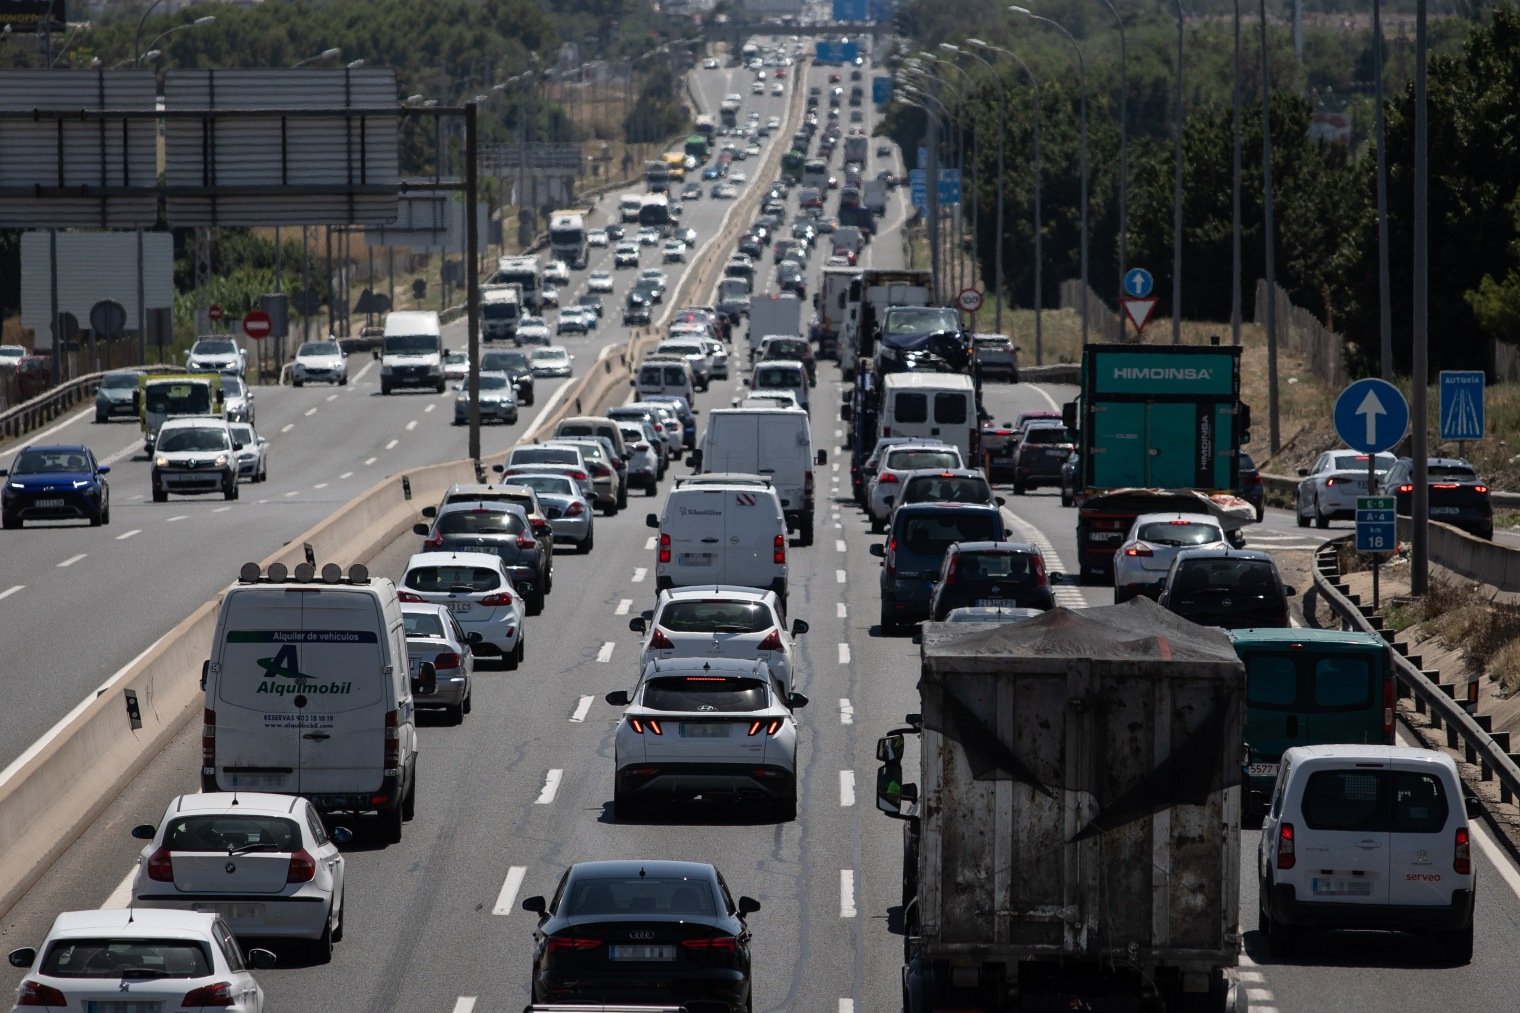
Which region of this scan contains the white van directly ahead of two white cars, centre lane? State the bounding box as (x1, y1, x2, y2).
(646, 485, 786, 608)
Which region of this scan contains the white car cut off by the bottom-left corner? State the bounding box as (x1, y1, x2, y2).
(11, 906, 275, 1013)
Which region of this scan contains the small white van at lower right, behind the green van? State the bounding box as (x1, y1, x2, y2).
(1257, 745, 1477, 964)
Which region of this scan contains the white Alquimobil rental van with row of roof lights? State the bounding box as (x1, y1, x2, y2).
(201, 563, 436, 841)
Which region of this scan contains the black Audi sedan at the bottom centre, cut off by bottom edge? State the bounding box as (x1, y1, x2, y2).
(523, 861, 760, 1013)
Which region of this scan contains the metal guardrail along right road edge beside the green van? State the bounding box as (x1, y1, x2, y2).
(1313, 535, 1520, 803)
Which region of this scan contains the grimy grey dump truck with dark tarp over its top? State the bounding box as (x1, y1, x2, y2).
(877, 598, 1245, 1013)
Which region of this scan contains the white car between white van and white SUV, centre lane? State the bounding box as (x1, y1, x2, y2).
(628, 584, 807, 689)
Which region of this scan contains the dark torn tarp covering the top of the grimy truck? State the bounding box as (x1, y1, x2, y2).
(920, 598, 1245, 841)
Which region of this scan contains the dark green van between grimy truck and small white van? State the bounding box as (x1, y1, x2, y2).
(1225, 628, 1395, 817)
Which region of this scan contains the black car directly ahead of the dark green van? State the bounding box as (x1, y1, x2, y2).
(1157, 549, 1298, 630)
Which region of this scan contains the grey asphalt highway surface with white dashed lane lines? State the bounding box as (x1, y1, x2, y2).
(0, 37, 1520, 1013)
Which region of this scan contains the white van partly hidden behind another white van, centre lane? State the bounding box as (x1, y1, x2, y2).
(693, 408, 828, 545)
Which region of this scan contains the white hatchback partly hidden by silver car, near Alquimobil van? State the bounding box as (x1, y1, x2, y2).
(397, 549, 526, 669)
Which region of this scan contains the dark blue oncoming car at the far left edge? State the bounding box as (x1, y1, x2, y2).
(0, 443, 111, 529)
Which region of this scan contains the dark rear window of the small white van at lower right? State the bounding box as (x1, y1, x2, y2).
(1301, 770, 1450, 834)
